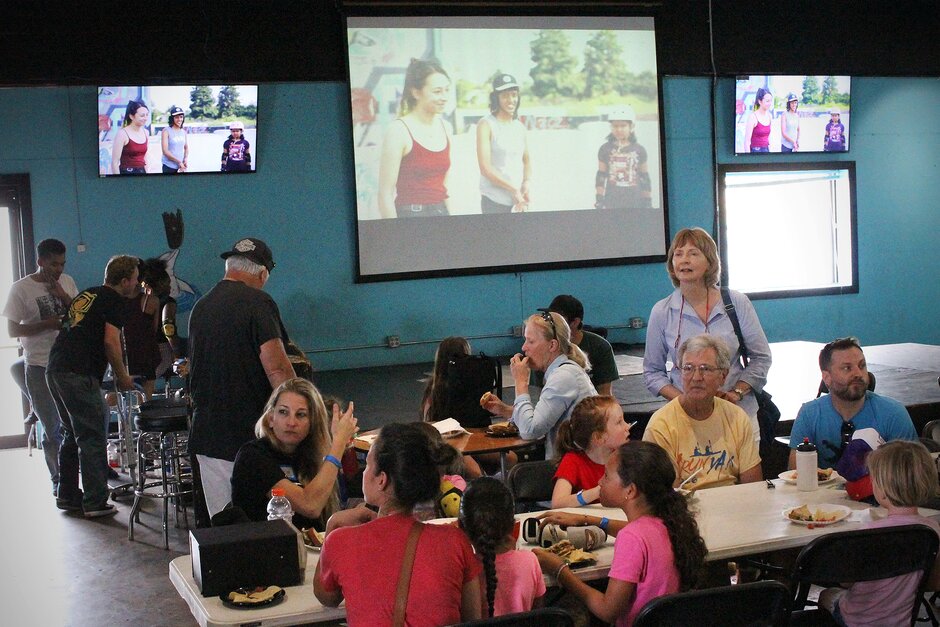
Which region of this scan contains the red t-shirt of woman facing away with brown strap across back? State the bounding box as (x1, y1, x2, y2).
(320, 514, 482, 627)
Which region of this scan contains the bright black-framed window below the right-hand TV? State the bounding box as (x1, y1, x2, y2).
(718, 161, 858, 299)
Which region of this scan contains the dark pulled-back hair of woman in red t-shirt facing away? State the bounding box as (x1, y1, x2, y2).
(372, 423, 452, 510)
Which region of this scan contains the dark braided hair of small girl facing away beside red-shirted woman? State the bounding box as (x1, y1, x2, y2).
(460, 477, 515, 616)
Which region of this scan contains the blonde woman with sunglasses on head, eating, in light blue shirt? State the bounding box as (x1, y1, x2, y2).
(483, 311, 597, 459)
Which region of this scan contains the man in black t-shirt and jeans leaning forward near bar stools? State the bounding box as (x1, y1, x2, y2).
(46, 255, 140, 518)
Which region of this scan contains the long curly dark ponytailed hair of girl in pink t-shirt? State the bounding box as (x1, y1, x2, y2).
(617, 441, 708, 590)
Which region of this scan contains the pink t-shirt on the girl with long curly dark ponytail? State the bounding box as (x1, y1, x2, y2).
(610, 516, 680, 627)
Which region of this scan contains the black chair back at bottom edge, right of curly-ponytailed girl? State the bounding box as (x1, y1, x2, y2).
(633, 581, 790, 627)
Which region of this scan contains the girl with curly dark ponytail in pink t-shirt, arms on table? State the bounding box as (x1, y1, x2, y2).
(533, 442, 707, 627)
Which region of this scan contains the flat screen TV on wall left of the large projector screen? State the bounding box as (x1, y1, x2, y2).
(98, 85, 258, 177)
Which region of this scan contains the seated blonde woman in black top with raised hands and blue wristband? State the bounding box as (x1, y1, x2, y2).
(232, 378, 357, 529)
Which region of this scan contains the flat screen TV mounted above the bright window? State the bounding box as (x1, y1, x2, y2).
(734, 75, 852, 155)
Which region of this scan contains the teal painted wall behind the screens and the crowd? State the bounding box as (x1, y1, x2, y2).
(0, 77, 940, 369)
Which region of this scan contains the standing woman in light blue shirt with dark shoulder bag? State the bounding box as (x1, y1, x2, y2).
(643, 227, 771, 439)
